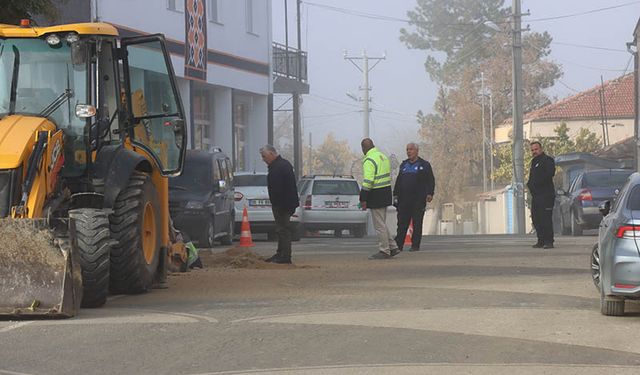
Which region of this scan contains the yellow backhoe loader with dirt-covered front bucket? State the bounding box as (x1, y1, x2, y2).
(0, 21, 187, 318)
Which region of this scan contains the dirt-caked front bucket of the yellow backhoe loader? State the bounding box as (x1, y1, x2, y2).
(0, 219, 82, 319)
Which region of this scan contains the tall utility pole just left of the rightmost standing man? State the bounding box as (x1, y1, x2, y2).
(511, 0, 525, 234)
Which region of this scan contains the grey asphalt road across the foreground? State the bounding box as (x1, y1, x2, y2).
(0, 236, 640, 375)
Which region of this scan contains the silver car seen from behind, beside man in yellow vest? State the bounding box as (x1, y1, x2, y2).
(298, 175, 367, 237)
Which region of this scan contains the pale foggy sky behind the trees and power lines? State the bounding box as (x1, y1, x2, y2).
(273, 0, 640, 157)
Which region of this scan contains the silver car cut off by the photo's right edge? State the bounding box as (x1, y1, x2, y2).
(591, 173, 640, 316)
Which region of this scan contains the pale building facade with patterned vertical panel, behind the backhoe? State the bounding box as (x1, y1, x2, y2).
(55, 0, 273, 171)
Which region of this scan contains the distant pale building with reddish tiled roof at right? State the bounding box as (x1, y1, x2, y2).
(494, 74, 635, 146)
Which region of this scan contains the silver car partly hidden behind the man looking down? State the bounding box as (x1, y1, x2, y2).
(233, 172, 300, 241)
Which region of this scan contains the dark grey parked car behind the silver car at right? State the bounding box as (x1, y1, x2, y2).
(557, 169, 633, 236)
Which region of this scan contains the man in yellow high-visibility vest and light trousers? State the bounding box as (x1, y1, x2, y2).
(360, 138, 400, 259)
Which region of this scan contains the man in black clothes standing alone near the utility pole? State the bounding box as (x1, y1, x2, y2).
(527, 141, 556, 249)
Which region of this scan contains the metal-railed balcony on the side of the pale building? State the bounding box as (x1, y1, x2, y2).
(272, 42, 309, 94)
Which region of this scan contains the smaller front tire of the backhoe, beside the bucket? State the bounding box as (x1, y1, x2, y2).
(69, 208, 114, 307)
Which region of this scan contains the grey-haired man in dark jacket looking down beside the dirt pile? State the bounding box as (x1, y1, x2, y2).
(260, 145, 300, 264)
